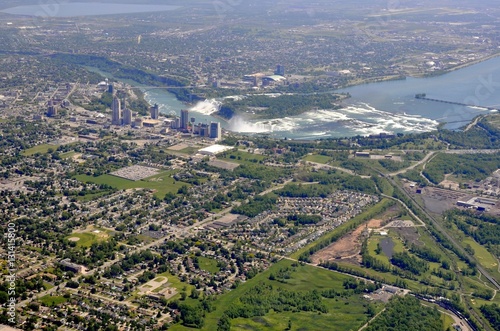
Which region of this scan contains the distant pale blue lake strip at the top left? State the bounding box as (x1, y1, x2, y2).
(0, 1, 180, 17)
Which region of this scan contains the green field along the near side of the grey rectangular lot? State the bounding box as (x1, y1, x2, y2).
(75, 172, 190, 198)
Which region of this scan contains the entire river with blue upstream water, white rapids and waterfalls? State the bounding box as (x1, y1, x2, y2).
(87, 57, 500, 139)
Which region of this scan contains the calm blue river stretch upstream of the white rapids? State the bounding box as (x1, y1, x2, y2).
(342, 57, 500, 128)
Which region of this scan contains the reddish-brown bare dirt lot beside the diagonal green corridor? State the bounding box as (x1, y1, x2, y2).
(312, 219, 383, 264)
